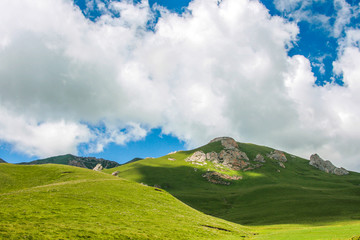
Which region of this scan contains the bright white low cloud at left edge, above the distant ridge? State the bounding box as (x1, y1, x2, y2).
(0, 108, 92, 157)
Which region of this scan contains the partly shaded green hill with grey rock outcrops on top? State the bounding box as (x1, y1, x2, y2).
(104, 138, 360, 239)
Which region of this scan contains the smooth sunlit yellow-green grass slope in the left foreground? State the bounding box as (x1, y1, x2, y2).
(0, 164, 251, 239)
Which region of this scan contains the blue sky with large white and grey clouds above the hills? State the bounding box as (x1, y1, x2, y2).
(0, 0, 360, 171)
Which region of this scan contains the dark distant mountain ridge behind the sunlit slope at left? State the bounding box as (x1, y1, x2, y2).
(19, 154, 120, 169)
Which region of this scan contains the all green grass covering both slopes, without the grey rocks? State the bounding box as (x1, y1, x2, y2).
(0, 142, 360, 240)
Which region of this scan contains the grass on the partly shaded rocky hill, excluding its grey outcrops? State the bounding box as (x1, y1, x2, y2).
(104, 142, 360, 239)
